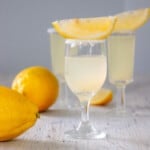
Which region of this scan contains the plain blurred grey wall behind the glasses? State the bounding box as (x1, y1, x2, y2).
(0, 0, 150, 74)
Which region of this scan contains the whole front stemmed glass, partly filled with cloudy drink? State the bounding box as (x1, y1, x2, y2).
(65, 39, 107, 139)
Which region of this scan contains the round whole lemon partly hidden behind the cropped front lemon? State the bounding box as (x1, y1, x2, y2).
(12, 66, 59, 112)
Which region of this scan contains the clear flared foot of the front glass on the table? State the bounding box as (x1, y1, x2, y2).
(65, 122, 106, 140)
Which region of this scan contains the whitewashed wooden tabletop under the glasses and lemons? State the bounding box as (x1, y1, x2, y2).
(0, 76, 150, 150)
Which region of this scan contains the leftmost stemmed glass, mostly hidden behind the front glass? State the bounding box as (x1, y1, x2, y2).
(48, 28, 79, 108)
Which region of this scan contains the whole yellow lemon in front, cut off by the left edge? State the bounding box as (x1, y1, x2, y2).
(0, 86, 38, 141)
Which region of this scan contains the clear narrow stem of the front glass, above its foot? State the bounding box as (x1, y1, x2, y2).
(81, 101, 90, 122)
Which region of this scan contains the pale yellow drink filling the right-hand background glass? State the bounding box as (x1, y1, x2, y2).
(108, 33, 135, 84)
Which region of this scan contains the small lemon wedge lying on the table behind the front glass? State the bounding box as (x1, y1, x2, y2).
(91, 88, 113, 105)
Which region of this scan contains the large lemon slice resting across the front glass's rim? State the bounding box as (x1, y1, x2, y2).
(52, 17, 117, 40)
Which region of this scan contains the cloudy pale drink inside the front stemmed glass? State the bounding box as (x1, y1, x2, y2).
(65, 55, 107, 101)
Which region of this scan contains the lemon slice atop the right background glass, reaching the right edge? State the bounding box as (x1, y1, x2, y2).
(113, 8, 150, 32)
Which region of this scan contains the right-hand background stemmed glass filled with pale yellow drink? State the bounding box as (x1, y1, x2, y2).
(108, 32, 135, 114)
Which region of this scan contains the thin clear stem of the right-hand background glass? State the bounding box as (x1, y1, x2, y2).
(116, 85, 126, 112)
